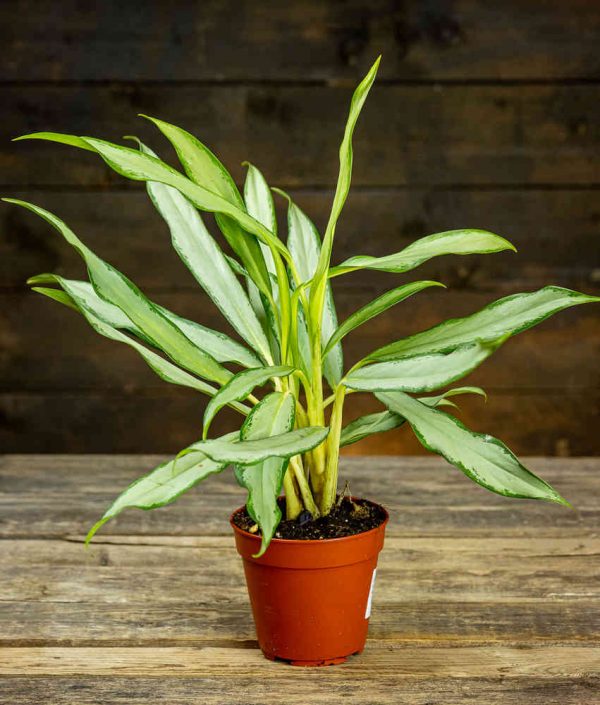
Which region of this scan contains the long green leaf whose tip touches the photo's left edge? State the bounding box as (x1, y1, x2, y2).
(4, 198, 233, 384)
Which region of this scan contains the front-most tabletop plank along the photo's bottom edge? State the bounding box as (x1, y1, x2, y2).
(2, 676, 598, 705)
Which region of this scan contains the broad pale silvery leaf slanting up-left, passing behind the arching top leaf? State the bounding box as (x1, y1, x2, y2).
(141, 145, 272, 362)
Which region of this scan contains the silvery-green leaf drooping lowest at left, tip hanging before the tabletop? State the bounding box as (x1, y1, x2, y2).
(85, 432, 238, 544)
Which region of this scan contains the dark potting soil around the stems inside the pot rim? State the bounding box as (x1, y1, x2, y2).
(233, 497, 385, 541)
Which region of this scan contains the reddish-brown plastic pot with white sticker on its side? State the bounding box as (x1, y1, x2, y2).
(231, 500, 388, 666)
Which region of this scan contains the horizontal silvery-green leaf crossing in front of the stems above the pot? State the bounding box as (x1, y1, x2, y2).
(186, 420, 329, 465)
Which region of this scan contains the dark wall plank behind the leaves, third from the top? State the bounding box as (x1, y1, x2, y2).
(0, 187, 600, 291)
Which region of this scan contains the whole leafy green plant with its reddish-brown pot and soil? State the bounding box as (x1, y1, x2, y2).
(5, 59, 600, 664)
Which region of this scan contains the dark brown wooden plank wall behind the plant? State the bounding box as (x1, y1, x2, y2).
(0, 0, 600, 455)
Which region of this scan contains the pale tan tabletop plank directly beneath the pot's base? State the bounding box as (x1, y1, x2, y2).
(0, 642, 600, 683)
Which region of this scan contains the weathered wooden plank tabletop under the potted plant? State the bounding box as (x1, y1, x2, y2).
(0, 455, 600, 705)
